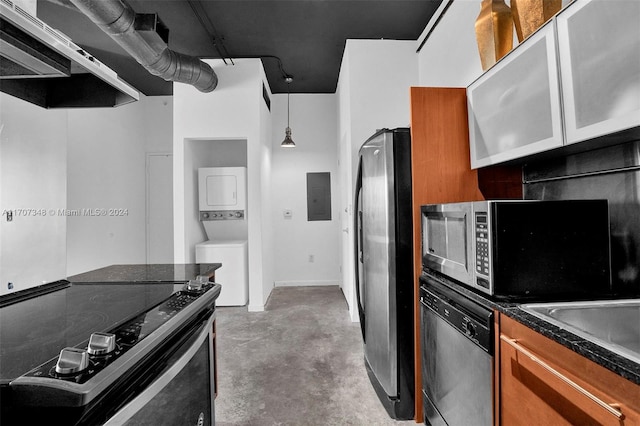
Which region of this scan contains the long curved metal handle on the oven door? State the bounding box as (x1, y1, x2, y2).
(104, 314, 215, 426)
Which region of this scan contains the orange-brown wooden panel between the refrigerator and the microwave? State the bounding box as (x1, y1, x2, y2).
(410, 87, 522, 423)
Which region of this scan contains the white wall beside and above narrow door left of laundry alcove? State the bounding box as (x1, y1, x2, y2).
(67, 96, 172, 275)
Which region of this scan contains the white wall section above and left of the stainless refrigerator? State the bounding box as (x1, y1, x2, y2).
(336, 40, 418, 321)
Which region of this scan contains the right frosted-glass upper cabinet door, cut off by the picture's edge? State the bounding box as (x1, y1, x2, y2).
(557, 0, 640, 144)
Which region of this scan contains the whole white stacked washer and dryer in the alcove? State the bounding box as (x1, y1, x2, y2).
(196, 167, 249, 306)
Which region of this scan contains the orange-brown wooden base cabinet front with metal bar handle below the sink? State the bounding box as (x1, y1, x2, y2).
(495, 314, 640, 426)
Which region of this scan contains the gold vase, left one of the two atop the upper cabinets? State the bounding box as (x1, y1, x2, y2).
(475, 0, 513, 70)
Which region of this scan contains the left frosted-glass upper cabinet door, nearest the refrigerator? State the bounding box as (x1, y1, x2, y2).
(467, 21, 563, 169)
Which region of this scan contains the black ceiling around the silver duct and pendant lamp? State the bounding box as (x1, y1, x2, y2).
(38, 0, 442, 96)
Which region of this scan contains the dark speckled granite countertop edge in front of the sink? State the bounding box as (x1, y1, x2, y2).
(420, 272, 640, 385)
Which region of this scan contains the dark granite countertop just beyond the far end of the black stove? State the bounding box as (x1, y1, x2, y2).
(67, 263, 222, 283)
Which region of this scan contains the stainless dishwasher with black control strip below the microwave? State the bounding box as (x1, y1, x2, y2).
(420, 274, 494, 426)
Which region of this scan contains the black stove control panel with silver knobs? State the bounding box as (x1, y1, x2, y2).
(25, 281, 214, 384)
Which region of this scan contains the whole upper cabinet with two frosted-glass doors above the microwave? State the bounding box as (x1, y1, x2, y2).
(467, 0, 640, 169)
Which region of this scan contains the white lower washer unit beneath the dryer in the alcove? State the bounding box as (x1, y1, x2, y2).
(196, 240, 249, 306)
